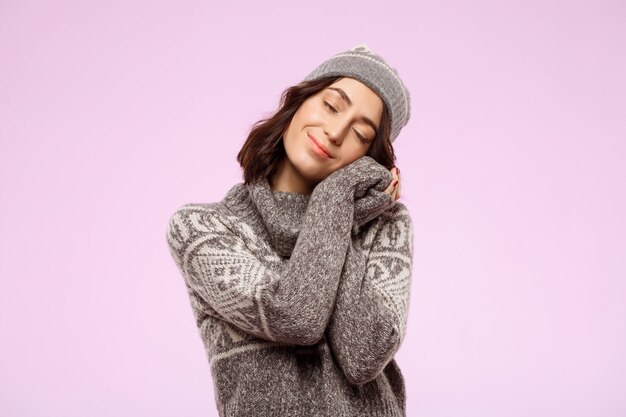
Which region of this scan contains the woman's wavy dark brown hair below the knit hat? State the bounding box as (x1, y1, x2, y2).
(237, 76, 396, 184)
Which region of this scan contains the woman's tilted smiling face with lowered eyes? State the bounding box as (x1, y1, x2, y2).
(283, 78, 383, 184)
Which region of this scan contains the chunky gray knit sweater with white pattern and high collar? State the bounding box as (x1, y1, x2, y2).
(167, 156, 413, 417)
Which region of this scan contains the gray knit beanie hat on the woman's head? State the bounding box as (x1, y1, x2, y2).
(304, 43, 411, 142)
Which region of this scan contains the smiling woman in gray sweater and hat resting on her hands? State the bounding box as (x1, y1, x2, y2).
(167, 44, 413, 417)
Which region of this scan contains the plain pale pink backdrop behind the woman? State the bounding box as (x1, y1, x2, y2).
(0, 0, 626, 417)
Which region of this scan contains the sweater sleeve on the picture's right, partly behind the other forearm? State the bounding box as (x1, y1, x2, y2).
(328, 203, 413, 384)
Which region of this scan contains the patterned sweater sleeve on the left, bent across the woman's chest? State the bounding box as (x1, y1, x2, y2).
(167, 179, 354, 345)
